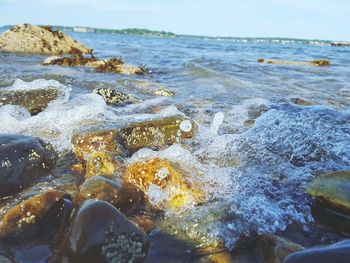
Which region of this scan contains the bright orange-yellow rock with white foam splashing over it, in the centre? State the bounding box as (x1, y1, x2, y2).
(124, 158, 203, 210)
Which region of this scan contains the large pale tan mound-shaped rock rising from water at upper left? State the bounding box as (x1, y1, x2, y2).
(0, 24, 92, 55)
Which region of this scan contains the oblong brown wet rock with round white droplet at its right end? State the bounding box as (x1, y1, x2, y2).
(119, 116, 195, 153)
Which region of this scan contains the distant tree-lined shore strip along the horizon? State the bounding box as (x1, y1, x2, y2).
(0, 25, 350, 47)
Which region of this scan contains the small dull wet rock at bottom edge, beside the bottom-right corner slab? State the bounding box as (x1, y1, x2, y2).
(258, 235, 304, 263)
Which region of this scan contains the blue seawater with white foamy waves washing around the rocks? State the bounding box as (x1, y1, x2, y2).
(0, 29, 350, 254)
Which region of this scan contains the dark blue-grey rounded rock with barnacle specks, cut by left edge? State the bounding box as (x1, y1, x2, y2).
(0, 134, 57, 196)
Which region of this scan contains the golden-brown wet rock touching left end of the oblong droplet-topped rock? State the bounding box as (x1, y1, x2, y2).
(72, 129, 123, 161)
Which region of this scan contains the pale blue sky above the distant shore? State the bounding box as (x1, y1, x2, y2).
(0, 0, 350, 41)
